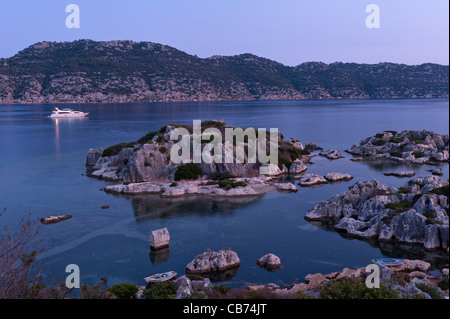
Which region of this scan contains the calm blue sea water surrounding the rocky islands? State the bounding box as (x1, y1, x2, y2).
(0, 99, 449, 286)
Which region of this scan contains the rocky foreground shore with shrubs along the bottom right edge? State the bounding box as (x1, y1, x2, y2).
(170, 254, 449, 299)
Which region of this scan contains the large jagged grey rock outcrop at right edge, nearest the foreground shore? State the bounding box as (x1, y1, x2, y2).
(305, 175, 449, 252)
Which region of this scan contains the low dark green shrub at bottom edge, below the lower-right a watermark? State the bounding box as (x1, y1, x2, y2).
(319, 278, 398, 299)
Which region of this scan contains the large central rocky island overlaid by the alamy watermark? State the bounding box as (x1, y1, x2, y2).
(86, 121, 316, 197)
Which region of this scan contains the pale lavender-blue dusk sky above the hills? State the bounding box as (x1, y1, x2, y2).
(0, 0, 449, 66)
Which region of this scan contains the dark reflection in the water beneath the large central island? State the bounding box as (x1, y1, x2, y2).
(114, 194, 260, 222)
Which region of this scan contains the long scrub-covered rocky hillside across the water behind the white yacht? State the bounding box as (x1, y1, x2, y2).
(0, 40, 449, 104)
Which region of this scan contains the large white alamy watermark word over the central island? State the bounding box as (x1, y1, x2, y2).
(170, 120, 279, 175)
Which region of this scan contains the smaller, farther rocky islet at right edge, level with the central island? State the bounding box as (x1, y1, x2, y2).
(347, 130, 449, 164)
